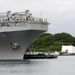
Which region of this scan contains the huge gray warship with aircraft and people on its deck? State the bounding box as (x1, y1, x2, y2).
(0, 10, 49, 60)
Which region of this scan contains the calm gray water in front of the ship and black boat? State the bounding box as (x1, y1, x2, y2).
(0, 56, 75, 75)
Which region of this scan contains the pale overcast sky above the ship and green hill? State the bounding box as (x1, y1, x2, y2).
(0, 0, 75, 37)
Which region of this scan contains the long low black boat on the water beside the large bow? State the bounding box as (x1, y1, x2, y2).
(24, 52, 58, 59)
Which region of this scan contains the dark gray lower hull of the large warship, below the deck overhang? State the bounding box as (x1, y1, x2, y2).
(0, 30, 44, 60)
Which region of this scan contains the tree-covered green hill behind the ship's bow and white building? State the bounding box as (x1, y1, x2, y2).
(29, 33, 75, 52)
